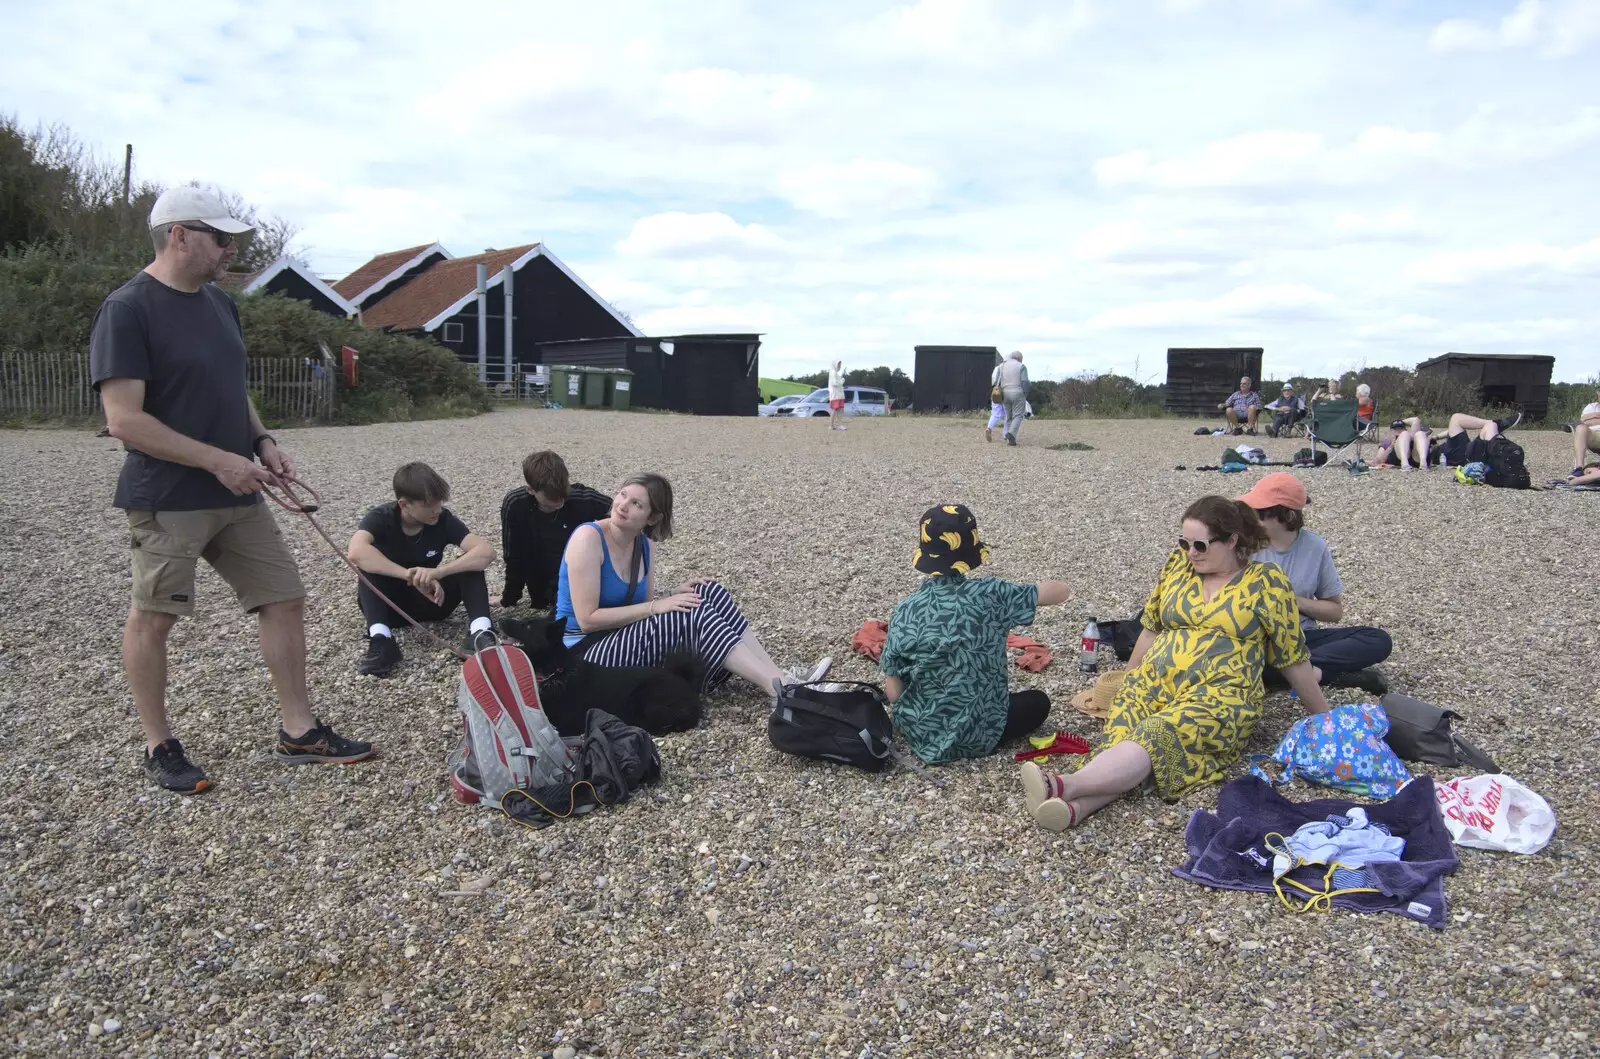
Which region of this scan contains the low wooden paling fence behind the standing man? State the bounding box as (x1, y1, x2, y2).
(0, 352, 339, 422)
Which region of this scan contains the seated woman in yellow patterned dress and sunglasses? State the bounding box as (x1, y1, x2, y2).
(1022, 496, 1328, 830)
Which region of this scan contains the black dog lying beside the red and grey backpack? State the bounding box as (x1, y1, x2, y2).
(501, 617, 706, 736)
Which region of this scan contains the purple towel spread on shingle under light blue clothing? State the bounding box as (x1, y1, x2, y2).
(1173, 776, 1459, 928)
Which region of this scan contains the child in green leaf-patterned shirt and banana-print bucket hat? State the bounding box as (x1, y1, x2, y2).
(878, 504, 1070, 765)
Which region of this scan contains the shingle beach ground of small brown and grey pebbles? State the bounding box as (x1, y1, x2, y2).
(0, 411, 1600, 1056)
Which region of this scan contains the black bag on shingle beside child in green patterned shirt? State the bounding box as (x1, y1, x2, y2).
(766, 680, 896, 773)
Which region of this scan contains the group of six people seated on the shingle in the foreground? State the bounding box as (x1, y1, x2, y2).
(349, 451, 1392, 830)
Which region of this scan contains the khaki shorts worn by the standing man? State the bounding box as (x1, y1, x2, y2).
(128, 504, 306, 614)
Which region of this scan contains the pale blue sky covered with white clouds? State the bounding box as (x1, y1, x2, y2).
(0, 0, 1600, 382)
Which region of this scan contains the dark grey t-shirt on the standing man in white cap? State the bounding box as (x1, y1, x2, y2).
(90, 272, 261, 510)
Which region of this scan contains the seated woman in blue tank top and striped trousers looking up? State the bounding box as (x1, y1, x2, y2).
(555, 474, 832, 693)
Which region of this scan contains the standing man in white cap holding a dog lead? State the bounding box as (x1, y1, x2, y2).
(90, 187, 373, 793)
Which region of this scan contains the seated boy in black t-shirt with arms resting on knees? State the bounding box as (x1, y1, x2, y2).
(349, 464, 499, 677)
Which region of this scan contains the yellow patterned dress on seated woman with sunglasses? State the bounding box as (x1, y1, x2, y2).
(1106, 552, 1310, 798)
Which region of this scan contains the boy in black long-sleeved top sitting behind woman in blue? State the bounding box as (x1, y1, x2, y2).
(490, 450, 611, 611)
